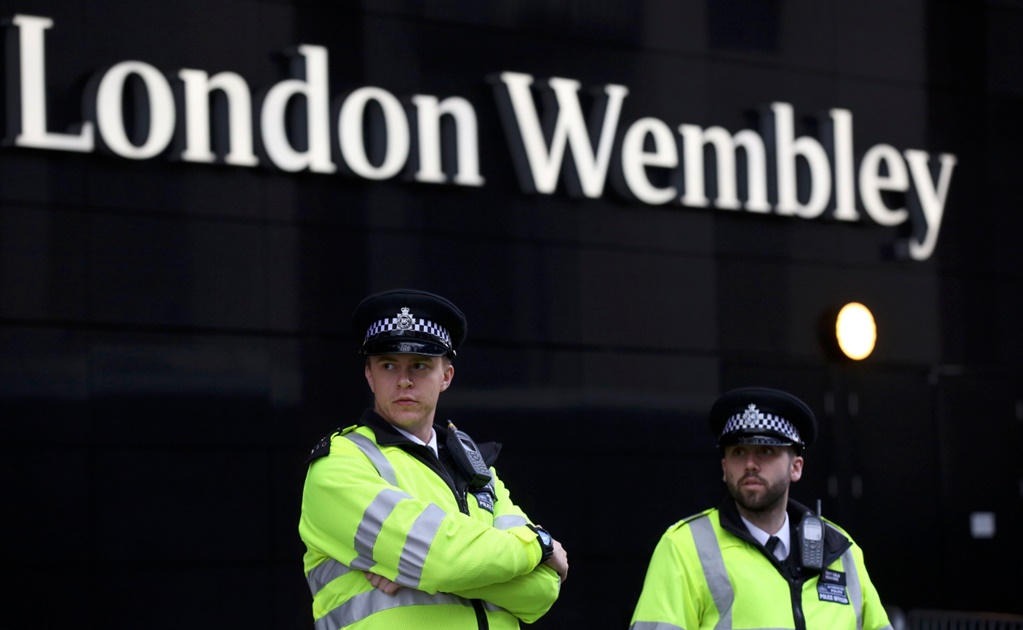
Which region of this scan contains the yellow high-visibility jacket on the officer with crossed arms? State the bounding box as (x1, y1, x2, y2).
(299, 410, 561, 630)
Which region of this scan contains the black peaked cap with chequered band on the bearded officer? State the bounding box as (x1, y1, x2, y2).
(709, 388, 817, 453)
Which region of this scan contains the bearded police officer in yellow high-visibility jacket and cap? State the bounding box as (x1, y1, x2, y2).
(631, 388, 891, 630)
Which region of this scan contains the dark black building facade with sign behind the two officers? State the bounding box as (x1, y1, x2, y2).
(0, 0, 1023, 630)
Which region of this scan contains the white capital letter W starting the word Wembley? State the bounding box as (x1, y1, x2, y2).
(494, 73, 629, 198)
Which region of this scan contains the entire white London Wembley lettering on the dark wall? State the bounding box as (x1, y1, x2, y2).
(6, 14, 957, 261)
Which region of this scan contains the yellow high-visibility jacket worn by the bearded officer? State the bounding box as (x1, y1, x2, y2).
(630, 499, 891, 630)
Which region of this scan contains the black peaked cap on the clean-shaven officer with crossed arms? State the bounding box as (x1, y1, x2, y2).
(352, 288, 469, 357)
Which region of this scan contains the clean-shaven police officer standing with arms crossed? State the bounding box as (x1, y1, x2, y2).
(299, 289, 568, 630)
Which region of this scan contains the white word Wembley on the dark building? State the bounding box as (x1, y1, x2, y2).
(492, 73, 955, 260)
